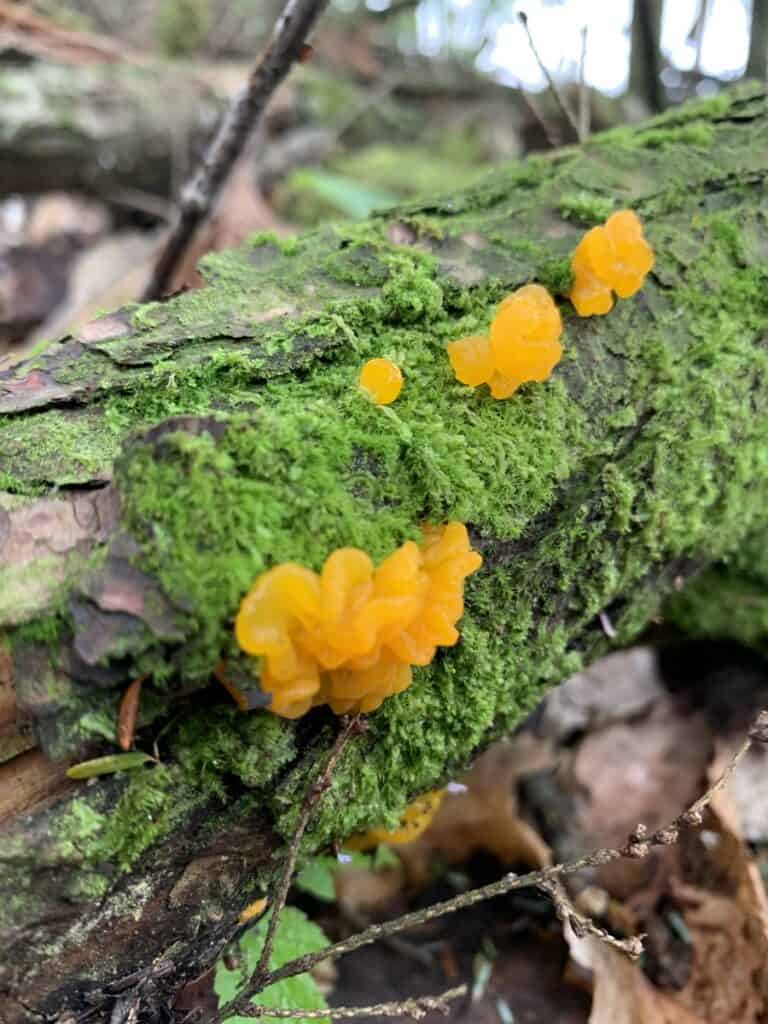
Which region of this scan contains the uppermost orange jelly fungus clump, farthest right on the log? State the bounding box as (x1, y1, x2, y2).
(569, 210, 653, 316)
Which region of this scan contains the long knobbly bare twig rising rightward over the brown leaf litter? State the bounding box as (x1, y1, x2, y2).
(224, 711, 768, 1016)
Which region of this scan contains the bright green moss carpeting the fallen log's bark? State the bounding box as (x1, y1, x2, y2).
(4, 86, 768, 880)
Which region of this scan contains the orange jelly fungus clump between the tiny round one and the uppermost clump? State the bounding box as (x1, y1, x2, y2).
(447, 285, 562, 398)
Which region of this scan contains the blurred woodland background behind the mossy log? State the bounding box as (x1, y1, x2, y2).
(0, 0, 768, 348)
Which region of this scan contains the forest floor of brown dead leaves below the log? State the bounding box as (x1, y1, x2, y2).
(173, 642, 768, 1024)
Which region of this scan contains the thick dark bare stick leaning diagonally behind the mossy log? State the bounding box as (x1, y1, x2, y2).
(143, 0, 328, 301)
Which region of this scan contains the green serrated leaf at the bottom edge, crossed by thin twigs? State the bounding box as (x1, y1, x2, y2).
(213, 906, 331, 1024)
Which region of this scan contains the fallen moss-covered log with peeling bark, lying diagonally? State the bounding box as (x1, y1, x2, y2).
(0, 87, 768, 1024)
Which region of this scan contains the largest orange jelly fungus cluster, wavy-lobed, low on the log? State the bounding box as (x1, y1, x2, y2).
(234, 522, 482, 718)
